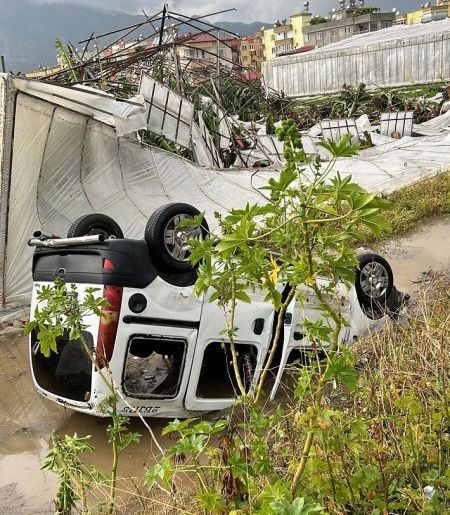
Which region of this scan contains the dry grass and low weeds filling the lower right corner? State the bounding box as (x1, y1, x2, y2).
(134, 276, 450, 515)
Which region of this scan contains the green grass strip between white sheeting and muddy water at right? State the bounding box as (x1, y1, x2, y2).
(358, 170, 450, 243)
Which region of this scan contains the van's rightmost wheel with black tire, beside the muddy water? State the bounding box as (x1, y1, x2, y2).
(355, 254, 394, 309)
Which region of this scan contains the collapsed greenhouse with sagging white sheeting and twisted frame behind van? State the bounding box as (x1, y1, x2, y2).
(0, 7, 450, 313)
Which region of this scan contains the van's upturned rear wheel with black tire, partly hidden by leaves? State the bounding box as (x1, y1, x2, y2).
(145, 203, 209, 274)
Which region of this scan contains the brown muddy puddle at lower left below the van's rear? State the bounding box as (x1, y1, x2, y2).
(0, 336, 175, 515)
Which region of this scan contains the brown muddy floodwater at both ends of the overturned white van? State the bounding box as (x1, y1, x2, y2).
(0, 218, 450, 515)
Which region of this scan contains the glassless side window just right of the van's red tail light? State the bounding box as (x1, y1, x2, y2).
(123, 335, 187, 398)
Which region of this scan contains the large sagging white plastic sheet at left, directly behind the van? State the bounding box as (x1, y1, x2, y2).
(0, 75, 261, 305)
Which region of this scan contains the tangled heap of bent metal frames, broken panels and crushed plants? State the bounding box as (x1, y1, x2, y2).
(30, 5, 450, 168)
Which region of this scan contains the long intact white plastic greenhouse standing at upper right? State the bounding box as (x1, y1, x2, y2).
(262, 19, 450, 96)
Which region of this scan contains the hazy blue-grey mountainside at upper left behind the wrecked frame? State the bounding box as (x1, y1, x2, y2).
(0, 0, 267, 72)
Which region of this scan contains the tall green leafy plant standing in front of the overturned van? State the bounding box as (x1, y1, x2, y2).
(147, 121, 402, 513)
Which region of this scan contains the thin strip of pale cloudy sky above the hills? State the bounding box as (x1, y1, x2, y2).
(34, 0, 400, 23)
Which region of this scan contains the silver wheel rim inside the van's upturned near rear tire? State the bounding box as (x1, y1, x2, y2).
(164, 214, 203, 263)
